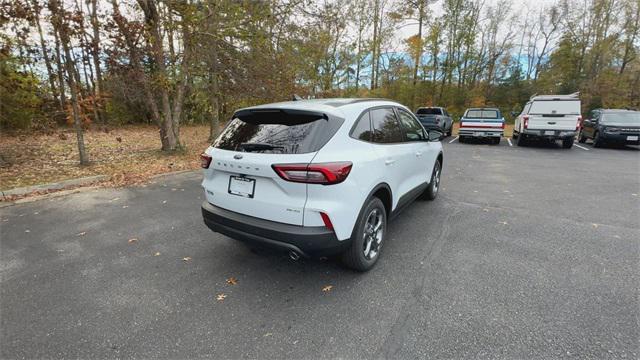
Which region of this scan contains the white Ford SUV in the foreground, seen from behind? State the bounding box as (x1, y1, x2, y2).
(202, 99, 443, 271)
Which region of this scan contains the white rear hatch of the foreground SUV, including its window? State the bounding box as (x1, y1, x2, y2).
(202, 108, 343, 225)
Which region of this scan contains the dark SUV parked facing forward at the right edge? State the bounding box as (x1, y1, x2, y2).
(578, 109, 640, 147)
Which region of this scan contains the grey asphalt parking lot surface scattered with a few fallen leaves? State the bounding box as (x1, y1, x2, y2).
(0, 138, 640, 359)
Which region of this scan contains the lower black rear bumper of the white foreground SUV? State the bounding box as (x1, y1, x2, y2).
(202, 201, 349, 257)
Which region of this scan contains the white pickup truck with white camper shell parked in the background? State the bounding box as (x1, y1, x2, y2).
(513, 93, 582, 149)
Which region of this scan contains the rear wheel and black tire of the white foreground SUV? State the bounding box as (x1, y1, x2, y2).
(342, 197, 387, 272)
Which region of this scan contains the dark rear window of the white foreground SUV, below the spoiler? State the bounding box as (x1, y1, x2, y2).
(213, 109, 343, 154)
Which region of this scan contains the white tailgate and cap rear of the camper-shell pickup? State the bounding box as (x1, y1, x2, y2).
(527, 99, 581, 131)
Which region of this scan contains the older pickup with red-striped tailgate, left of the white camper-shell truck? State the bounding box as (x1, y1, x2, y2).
(458, 108, 504, 145)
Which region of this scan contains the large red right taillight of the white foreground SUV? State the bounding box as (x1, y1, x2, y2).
(271, 161, 353, 185)
